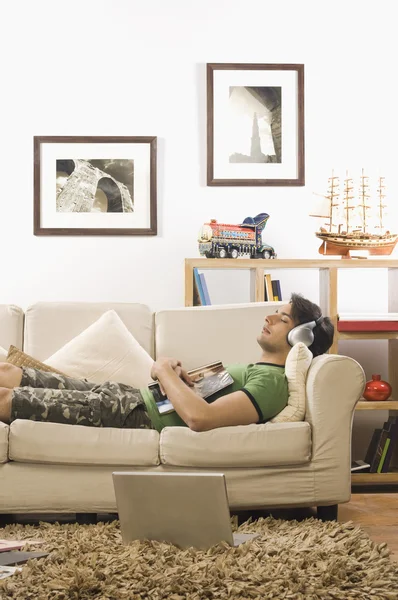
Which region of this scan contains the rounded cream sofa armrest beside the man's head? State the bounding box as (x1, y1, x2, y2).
(305, 354, 366, 499)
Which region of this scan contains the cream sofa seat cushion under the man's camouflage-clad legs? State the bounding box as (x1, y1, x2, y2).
(9, 419, 159, 466)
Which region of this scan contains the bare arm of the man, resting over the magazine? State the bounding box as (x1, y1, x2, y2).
(152, 358, 259, 431)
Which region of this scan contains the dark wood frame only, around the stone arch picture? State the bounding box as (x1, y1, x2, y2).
(33, 136, 157, 235)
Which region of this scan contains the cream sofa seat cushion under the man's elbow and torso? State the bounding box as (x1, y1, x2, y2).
(160, 422, 311, 468)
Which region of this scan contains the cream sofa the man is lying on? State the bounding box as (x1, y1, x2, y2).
(0, 302, 365, 518)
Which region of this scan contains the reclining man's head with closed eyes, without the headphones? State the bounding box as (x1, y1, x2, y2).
(257, 294, 334, 356)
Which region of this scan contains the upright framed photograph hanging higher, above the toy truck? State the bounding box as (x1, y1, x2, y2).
(207, 63, 305, 186)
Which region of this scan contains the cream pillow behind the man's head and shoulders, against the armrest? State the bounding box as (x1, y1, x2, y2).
(270, 342, 312, 423)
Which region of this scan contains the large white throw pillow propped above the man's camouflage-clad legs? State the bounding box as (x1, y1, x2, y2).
(44, 310, 153, 388)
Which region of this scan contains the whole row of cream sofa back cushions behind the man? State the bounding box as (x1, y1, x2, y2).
(0, 302, 284, 369)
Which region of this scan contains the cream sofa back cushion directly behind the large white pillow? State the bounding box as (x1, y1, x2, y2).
(23, 302, 153, 360)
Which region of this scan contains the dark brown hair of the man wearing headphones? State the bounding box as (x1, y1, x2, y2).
(290, 294, 334, 356)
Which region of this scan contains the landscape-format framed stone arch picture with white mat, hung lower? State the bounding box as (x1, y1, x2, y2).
(34, 136, 157, 235)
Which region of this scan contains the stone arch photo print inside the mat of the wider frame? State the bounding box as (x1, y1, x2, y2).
(56, 159, 134, 213)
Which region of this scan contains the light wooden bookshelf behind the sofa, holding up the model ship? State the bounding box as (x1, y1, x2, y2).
(185, 258, 398, 486)
